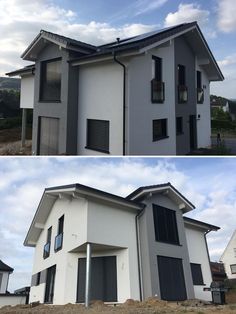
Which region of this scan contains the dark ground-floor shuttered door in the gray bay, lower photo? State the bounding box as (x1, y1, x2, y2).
(157, 256, 187, 301)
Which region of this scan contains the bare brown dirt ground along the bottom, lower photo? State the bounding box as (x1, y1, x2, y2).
(0, 298, 236, 314)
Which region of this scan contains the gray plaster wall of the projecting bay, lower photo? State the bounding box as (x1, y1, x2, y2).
(139, 194, 194, 299)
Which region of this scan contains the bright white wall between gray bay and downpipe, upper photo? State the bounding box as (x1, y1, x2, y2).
(78, 61, 123, 155)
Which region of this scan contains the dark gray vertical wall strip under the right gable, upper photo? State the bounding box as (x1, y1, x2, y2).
(175, 36, 197, 155)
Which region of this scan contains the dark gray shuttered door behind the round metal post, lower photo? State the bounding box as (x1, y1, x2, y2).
(77, 256, 117, 302)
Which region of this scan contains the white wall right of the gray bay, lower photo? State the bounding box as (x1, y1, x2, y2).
(185, 224, 212, 301)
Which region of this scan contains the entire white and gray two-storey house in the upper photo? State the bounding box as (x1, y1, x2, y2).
(8, 22, 224, 155)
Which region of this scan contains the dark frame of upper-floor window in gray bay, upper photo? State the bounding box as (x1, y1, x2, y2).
(39, 58, 62, 103)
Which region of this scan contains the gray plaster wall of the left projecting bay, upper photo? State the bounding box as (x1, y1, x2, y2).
(32, 44, 78, 155)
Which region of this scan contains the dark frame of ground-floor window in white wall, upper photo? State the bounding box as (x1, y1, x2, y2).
(85, 119, 110, 154)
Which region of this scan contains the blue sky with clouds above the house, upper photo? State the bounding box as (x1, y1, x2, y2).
(0, 0, 236, 98)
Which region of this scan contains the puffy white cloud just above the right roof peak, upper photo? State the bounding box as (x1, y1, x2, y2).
(165, 3, 210, 27)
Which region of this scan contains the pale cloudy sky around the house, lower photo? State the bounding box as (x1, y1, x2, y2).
(0, 157, 236, 291)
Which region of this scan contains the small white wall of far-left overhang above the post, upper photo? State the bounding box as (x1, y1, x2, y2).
(20, 74, 34, 109)
